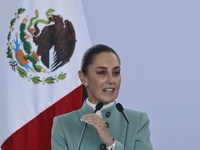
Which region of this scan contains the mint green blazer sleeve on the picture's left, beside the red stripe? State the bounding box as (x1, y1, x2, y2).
(51, 117, 68, 150)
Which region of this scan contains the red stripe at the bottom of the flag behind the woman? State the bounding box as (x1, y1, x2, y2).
(1, 86, 82, 150)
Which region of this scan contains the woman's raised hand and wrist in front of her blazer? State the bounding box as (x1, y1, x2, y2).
(81, 113, 113, 147)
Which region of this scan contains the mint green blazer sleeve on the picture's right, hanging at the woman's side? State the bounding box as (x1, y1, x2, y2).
(134, 113, 153, 150)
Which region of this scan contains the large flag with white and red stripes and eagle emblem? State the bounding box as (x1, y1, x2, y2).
(0, 0, 91, 150)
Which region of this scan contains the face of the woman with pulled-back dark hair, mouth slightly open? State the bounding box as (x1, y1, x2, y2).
(80, 52, 121, 104)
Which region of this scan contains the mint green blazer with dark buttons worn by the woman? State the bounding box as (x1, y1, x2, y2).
(51, 103, 153, 150)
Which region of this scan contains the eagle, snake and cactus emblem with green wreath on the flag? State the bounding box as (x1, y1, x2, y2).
(6, 8, 76, 84)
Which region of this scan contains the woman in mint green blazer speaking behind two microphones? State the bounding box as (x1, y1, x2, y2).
(52, 44, 153, 150)
